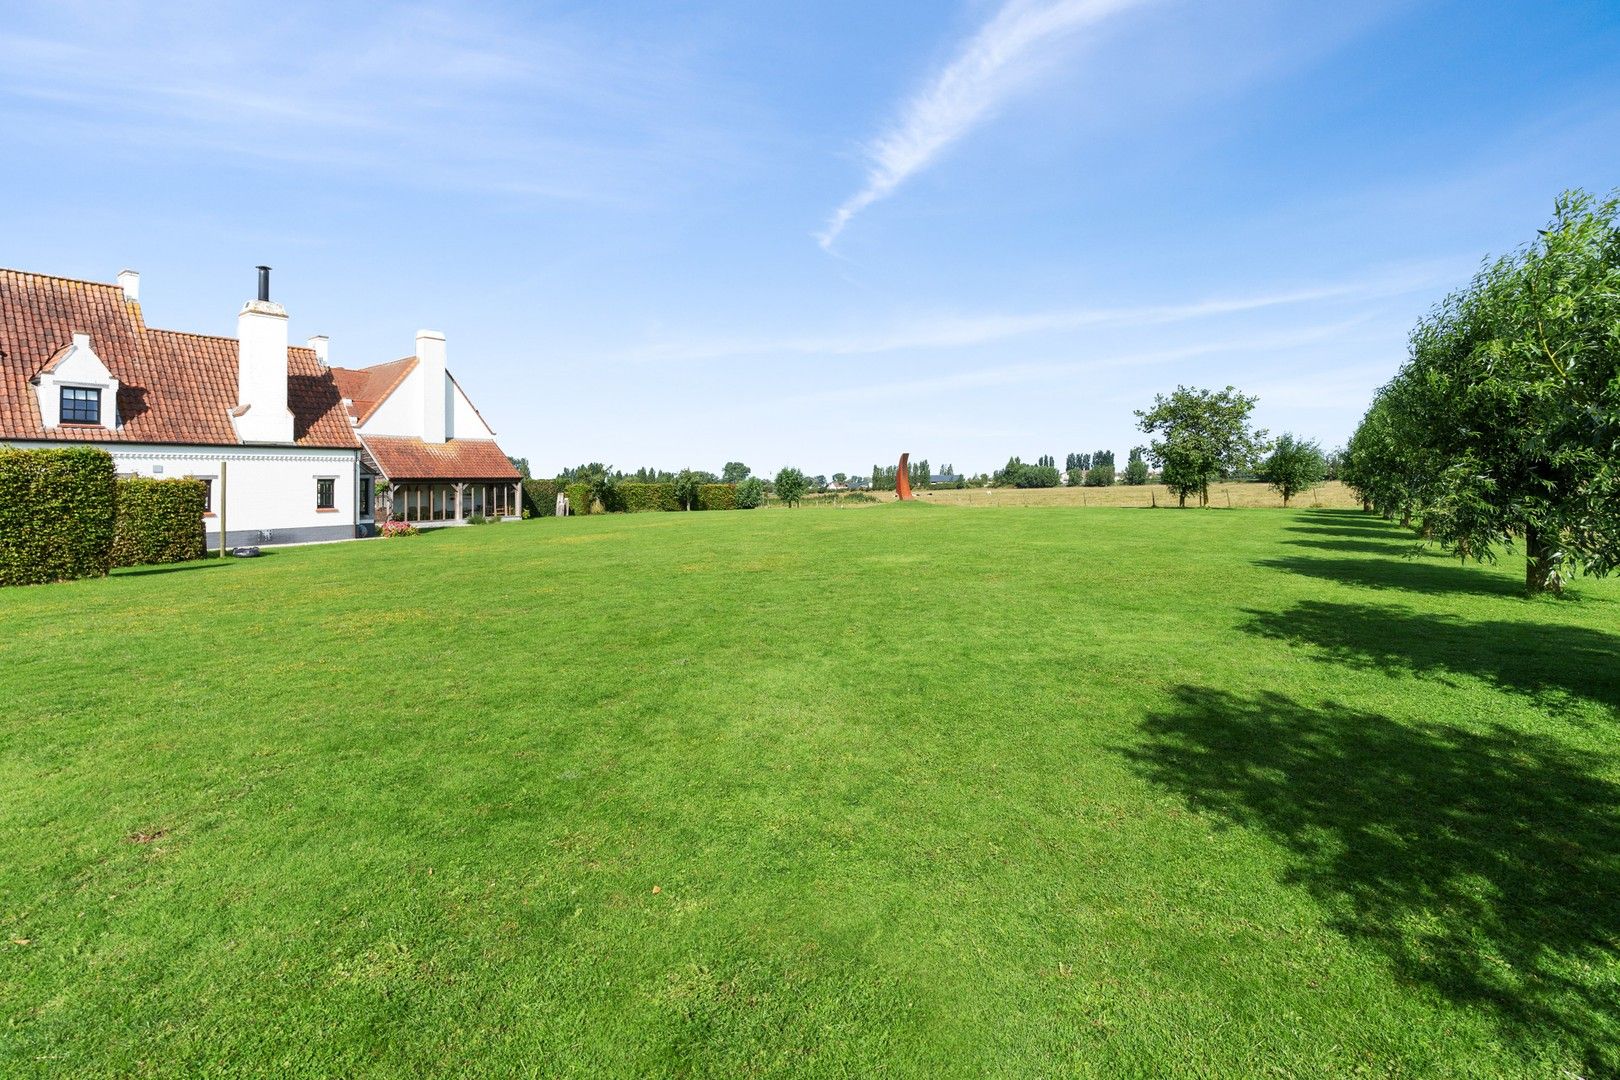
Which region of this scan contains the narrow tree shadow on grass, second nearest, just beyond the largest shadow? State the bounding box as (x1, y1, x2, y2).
(1241, 601, 1620, 716)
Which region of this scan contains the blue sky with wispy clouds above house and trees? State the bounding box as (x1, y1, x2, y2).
(0, 0, 1620, 474)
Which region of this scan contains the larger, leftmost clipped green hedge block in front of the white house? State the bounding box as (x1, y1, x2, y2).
(0, 447, 118, 585)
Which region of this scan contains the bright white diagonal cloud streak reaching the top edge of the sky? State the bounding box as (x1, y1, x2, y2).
(816, 0, 1149, 251)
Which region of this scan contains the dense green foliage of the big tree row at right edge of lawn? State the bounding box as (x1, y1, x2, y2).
(1345, 193, 1620, 591)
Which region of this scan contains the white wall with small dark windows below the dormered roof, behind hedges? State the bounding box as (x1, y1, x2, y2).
(11, 442, 360, 542)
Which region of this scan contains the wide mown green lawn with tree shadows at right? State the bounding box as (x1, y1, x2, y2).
(0, 505, 1620, 1077)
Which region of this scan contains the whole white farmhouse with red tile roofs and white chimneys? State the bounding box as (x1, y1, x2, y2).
(0, 267, 520, 546)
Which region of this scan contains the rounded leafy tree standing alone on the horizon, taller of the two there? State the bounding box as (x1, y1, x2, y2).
(1136, 387, 1265, 505)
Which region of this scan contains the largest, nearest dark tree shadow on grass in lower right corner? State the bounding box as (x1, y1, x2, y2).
(1126, 687, 1620, 1077)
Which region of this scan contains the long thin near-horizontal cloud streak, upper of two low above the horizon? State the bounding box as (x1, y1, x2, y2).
(617, 261, 1463, 363)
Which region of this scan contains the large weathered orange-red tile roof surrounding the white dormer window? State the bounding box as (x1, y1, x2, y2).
(0, 269, 360, 447)
